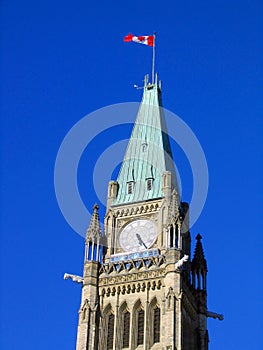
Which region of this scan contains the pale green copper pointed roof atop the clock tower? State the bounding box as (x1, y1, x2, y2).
(113, 76, 176, 205)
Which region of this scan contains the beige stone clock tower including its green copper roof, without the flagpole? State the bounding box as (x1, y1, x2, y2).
(67, 75, 222, 350)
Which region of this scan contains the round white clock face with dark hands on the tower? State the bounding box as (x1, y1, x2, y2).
(120, 220, 157, 252)
